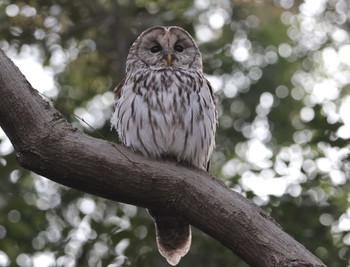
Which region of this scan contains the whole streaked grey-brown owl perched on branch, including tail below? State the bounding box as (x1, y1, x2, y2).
(111, 26, 217, 265)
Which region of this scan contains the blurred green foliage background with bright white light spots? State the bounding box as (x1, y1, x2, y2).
(0, 0, 350, 267)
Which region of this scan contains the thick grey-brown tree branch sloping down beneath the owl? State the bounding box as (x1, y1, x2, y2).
(0, 51, 325, 267)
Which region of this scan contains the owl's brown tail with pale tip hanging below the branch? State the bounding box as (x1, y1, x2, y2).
(150, 211, 192, 266)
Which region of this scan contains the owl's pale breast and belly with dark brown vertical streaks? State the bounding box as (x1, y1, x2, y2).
(111, 71, 216, 168)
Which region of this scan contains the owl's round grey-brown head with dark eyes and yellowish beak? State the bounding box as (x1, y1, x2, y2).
(127, 26, 202, 71)
